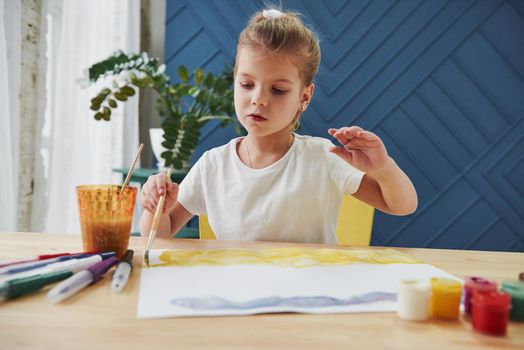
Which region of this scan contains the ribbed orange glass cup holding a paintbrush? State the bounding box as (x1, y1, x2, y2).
(76, 185, 137, 258)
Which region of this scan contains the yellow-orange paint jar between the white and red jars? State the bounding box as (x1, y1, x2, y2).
(431, 278, 462, 320)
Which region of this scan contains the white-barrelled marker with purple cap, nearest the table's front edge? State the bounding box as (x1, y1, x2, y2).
(47, 256, 118, 304)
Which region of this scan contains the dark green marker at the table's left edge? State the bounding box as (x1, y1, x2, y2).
(0, 270, 73, 301)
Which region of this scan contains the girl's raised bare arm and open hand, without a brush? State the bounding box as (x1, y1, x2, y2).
(328, 126, 418, 215)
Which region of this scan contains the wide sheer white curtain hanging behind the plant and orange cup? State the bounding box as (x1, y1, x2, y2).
(31, 0, 140, 234)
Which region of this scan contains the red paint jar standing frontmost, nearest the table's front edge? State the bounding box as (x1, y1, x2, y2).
(471, 291, 511, 336)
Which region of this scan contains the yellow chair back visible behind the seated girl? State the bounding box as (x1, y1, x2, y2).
(199, 196, 375, 246)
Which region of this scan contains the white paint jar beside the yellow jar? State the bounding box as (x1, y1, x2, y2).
(397, 280, 431, 321)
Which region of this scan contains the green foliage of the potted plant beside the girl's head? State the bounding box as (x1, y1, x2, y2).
(85, 51, 241, 169)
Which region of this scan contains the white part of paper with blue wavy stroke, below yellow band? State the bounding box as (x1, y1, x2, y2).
(137, 250, 456, 318)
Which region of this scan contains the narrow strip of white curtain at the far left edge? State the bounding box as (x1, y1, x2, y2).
(0, 0, 21, 231)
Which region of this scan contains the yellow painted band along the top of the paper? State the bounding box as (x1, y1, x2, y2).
(151, 248, 420, 267)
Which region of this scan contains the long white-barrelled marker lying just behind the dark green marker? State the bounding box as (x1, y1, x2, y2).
(0, 252, 116, 283)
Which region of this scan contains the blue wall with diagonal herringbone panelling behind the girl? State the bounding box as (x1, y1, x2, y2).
(165, 0, 524, 251)
